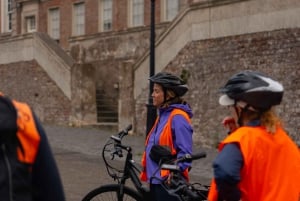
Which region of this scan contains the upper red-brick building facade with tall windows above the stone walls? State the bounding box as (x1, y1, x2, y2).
(1, 0, 192, 49)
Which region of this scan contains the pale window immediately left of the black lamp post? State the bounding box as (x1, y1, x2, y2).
(128, 0, 144, 26)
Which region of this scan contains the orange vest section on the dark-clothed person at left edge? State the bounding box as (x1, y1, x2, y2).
(0, 92, 40, 164)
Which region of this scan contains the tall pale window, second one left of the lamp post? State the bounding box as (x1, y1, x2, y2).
(100, 0, 112, 31)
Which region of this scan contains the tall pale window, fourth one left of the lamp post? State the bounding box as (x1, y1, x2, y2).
(48, 8, 60, 40)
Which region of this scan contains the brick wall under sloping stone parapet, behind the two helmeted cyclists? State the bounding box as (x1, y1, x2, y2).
(135, 28, 300, 147)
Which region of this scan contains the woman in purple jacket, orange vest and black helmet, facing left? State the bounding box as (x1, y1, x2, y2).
(140, 72, 193, 201)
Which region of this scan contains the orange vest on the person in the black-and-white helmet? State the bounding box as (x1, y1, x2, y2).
(208, 127, 300, 201)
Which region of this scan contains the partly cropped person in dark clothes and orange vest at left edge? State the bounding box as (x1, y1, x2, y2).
(0, 93, 65, 201)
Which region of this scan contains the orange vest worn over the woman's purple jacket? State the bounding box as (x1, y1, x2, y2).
(140, 109, 191, 181)
